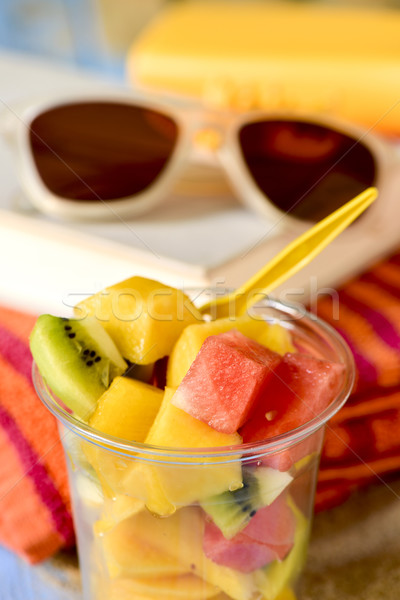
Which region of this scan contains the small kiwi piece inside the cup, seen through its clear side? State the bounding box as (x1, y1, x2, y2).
(201, 466, 293, 539)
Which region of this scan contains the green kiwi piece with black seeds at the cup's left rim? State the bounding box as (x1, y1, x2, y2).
(30, 315, 128, 421)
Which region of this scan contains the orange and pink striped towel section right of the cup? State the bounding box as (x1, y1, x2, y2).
(316, 253, 400, 510)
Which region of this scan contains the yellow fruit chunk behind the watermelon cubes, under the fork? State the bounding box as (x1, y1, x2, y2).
(167, 315, 294, 387)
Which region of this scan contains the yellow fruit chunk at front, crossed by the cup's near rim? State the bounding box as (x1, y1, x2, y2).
(121, 388, 243, 515)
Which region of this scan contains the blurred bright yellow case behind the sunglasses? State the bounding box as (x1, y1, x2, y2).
(127, 0, 400, 132)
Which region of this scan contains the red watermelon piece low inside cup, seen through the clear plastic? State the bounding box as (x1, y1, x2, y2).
(203, 494, 296, 573)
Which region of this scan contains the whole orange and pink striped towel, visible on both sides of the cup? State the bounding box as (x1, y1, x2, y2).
(0, 252, 400, 563)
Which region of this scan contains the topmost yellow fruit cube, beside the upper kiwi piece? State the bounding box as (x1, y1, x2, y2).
(75, 277, 202, 364)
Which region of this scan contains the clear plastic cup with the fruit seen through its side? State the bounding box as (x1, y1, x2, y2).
(33, 300, 354, 600)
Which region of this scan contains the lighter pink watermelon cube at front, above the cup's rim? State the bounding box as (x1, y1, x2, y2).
(172, 330, 282, 434)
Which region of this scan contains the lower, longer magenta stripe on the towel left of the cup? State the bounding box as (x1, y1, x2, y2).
(0, 406, 75, 546)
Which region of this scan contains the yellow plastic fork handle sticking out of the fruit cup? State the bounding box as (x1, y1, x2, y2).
(200, 187, 378, 319)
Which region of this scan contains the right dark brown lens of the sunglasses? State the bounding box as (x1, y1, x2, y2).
(239, 120, 377, 221)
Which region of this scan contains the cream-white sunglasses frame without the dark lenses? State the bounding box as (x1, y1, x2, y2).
(3, 93, 399, 227)
